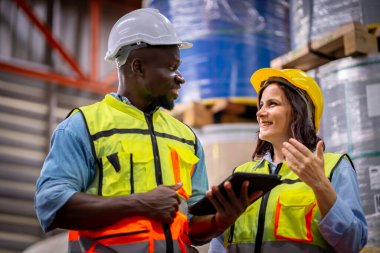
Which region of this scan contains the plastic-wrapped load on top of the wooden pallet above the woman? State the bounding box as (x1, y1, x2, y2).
(290, 0, 380, 50)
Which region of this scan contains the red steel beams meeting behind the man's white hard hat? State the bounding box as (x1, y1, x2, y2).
(0, 0, 141, 94)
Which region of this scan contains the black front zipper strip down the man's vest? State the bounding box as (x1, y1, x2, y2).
(144, 112, 174, 253)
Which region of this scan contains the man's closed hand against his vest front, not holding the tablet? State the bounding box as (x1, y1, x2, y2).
(136, 183, 182, 223)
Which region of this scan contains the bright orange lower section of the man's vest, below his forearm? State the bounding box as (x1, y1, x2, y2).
(69, 212, 191, 253)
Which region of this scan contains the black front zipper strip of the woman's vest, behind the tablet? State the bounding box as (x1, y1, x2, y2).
(254, 163, 282, 253)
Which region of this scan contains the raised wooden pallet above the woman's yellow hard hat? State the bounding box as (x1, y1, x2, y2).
(270, 22, 378, 71)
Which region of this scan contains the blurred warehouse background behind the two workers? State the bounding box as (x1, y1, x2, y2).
(0, 0, 380, 253)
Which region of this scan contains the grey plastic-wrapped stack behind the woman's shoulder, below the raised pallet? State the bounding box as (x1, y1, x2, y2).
(315, 54, 380, 250)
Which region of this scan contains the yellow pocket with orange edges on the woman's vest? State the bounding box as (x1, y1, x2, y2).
(274, 188, 316, 242)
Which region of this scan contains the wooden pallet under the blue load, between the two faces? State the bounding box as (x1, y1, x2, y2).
(169, 98, 257, 128)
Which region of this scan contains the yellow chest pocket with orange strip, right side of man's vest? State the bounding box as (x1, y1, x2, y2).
(169, 144, 199, 199)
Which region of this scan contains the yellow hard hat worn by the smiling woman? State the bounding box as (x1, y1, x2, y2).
(250, 68, 323, 132)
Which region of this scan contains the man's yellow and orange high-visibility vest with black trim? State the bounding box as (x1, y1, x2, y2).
(69, 95, 199, 253)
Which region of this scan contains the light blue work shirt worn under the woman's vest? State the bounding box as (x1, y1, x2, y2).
(209, 152, 368, 253)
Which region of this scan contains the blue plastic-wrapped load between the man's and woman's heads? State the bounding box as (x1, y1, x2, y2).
(146, 0, 289, 102)
